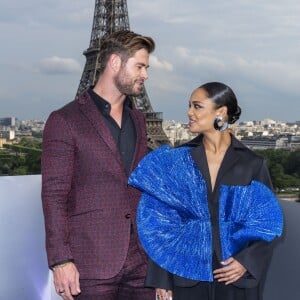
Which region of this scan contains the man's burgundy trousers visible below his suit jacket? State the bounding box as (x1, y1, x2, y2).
(75, 233, 155, 300)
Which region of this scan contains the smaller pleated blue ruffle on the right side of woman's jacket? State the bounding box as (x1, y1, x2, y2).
(219, 181, 283, 259)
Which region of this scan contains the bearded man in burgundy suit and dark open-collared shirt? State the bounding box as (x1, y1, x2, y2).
(42, 31, 155, 300)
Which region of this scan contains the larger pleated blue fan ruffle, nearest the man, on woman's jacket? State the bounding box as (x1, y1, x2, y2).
(129, 146, 213, 281)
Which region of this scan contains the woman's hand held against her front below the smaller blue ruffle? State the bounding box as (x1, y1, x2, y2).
(214, 257, 247, 285)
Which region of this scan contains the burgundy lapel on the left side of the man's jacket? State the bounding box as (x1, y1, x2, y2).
(78, 92, 123, 166)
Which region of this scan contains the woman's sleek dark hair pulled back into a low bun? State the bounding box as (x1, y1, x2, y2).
(199, 82, 242, 124)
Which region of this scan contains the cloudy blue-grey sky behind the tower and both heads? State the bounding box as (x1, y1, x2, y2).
(0, 0, 300, 122)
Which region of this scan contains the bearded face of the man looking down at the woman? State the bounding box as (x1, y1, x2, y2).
(115, 49, 149, 96)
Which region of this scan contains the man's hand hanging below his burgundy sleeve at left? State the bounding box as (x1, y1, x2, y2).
(53, 262, 81, 300)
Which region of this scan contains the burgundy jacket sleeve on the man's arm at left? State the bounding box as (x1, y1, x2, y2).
(42, 112, 75, 266)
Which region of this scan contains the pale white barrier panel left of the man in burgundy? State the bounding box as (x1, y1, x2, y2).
(0, 175, 61, 300)
